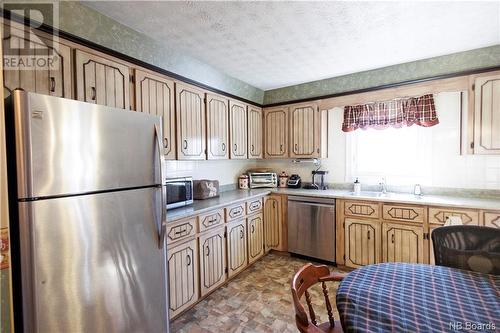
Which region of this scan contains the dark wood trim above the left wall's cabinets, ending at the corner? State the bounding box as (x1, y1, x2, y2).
(0, 10, 262, 107)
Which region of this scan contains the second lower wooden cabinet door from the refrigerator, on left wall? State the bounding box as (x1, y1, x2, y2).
(199, 228, 226, 296)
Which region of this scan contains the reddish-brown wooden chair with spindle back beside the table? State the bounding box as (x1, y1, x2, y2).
(292, 264, 345, 333)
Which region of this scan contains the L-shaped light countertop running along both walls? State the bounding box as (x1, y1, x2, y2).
(167, 188, 500, 222)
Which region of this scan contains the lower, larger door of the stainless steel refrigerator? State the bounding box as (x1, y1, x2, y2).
(19, 188, 168, 332)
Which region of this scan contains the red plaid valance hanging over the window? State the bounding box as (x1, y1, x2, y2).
(342, 94, 439, 132)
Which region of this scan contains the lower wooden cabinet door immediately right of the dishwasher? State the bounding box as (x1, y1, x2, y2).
(344, 218, 381, 267)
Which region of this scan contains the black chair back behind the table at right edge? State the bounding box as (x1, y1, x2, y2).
(432, 225, 500, 275)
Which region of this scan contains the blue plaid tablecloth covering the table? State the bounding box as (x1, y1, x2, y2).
(337, 263, 500, 333)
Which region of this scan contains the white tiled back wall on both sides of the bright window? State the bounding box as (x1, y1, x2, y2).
(259, 92, 500, 190)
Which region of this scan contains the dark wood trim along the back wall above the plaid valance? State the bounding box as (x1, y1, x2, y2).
(264, 66, 500, 108)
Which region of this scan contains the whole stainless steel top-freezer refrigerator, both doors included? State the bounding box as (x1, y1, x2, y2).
(10, 91, 168, 332)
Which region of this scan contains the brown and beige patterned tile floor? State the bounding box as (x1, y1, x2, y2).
(171, 253, 348, 333)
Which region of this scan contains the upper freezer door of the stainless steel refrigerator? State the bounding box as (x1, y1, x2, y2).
(13, 91, 162, 199)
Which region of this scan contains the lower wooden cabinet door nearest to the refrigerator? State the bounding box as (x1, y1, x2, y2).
(167, 239, 199, 318)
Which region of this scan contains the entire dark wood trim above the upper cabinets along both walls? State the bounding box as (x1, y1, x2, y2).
(1, 11, 500, 108)
